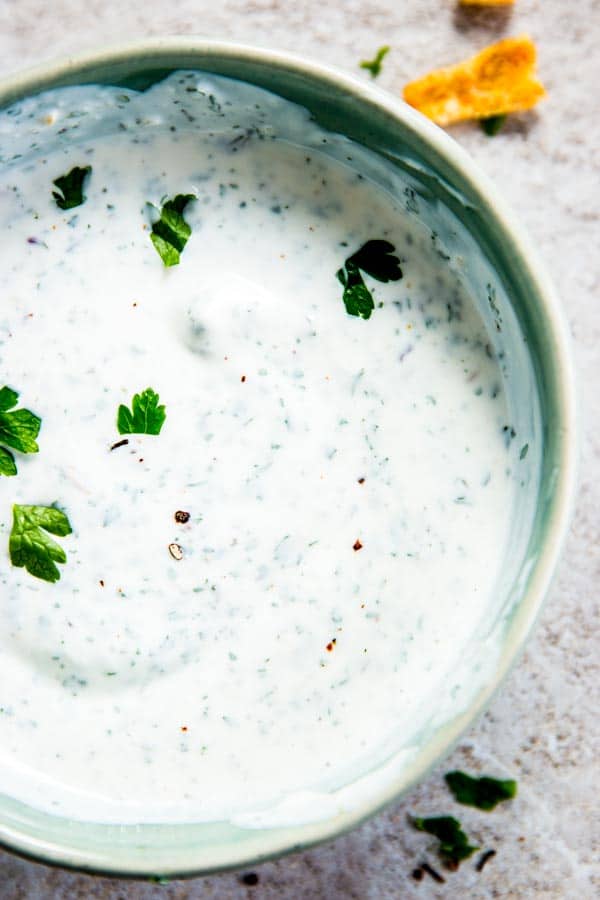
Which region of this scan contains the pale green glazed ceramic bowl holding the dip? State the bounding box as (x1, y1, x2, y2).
(0, 38, 576, 877)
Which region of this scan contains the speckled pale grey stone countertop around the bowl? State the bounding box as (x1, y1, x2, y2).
(0, 0, 600, 900)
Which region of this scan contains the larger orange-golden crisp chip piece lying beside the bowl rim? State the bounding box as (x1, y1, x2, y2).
(404, 35, 546, 125)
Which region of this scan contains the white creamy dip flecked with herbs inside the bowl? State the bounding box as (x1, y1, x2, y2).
(0, 74, 518, 822)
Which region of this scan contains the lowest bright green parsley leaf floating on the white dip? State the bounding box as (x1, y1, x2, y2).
(8, 503, 71, 582)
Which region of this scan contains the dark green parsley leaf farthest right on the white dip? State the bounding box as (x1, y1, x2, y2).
(336, 240, 402, 319)
